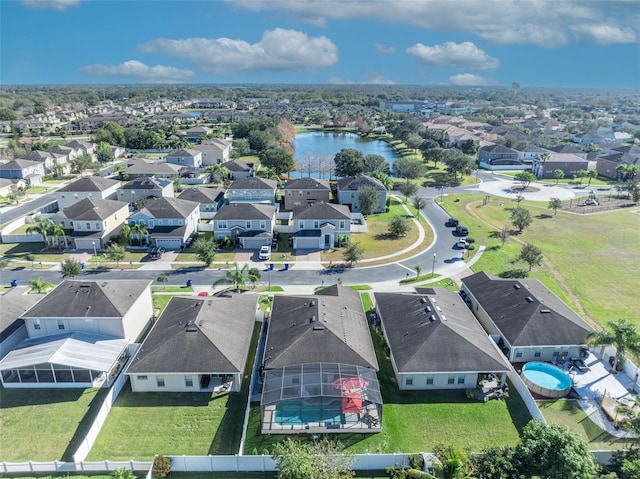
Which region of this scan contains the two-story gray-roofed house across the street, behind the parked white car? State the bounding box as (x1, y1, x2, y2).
(213, 203, 276, 249)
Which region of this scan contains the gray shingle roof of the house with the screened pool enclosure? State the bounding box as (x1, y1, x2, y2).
(264, 285, 378, 370)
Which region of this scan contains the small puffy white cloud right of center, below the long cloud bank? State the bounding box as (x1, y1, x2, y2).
(407, 42, 500, 70)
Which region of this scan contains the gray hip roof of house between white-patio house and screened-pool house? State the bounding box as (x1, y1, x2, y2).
(127, 295, 258, 373)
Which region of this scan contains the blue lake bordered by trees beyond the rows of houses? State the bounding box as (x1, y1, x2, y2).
(291, 131, 398, 180)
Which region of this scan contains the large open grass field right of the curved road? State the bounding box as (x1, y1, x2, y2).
(443, 195, 640, 327)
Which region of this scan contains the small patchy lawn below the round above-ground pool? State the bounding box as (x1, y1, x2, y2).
(538, 399, 640, 450)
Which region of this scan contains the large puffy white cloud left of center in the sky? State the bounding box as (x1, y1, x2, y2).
(138, 28, 338, 75)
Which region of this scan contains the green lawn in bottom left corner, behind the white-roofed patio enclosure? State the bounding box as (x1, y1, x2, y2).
(0, 388, 107, 462)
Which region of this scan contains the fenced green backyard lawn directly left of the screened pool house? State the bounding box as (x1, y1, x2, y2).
(87, 324, 260, 461)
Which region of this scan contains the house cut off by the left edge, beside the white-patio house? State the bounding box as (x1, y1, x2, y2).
(0, 286, 44, 359)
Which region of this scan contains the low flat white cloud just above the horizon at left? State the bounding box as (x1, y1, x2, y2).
(79, 60, 195, 83)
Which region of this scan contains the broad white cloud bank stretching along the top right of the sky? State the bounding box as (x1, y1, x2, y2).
(225, 0, 640, 48)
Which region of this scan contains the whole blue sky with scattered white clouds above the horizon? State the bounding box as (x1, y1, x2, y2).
(0, 0, 640, 88)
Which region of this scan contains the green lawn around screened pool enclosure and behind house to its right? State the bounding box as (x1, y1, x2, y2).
(244, 326, 531, 454)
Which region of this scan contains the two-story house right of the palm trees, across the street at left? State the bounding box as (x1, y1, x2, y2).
(128, 197, 200, 250)
